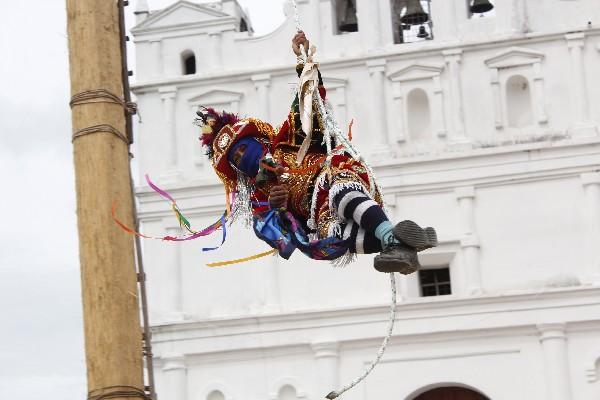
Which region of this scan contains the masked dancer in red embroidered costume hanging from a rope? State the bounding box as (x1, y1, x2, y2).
(196, 32, 437, 274)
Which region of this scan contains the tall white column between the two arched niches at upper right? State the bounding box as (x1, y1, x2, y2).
(442, 49, 468, 143)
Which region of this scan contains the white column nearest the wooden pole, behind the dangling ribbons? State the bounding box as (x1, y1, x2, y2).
(162, 226, 183, 321)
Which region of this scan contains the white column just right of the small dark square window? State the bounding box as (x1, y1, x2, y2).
(454, 186, 483, 295)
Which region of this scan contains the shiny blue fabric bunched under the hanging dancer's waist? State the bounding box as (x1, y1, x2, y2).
(254, 208, 349, 260)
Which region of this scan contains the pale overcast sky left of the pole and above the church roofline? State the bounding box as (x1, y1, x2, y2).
(0, 0, 284, 400)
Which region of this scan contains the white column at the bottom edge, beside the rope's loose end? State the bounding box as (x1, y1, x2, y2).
(311, 341, 339, 398)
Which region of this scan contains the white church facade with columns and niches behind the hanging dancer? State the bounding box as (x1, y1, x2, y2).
(131, 0, 600, 400)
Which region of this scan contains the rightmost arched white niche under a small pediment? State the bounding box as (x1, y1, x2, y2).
(506, 75, 533, 128)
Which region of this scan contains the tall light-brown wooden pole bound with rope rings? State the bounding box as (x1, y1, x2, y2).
(66, 0, 144, 400)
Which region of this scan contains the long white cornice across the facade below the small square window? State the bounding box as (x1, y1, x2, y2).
(152, 286, 600, 363)
